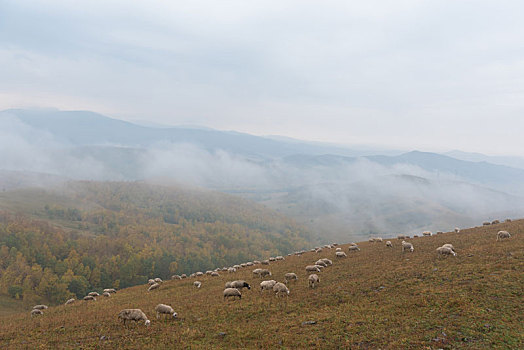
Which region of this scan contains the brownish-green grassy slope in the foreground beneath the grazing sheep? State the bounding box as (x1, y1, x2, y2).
(0, 220, 524, 349)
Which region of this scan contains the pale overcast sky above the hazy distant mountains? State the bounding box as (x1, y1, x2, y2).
(0, 0, 524, 155)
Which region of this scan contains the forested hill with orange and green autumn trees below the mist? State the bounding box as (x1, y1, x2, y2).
(0, 182, 310, 305)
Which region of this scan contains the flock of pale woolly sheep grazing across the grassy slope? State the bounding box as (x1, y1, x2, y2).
(27, 219, 511, 326)
